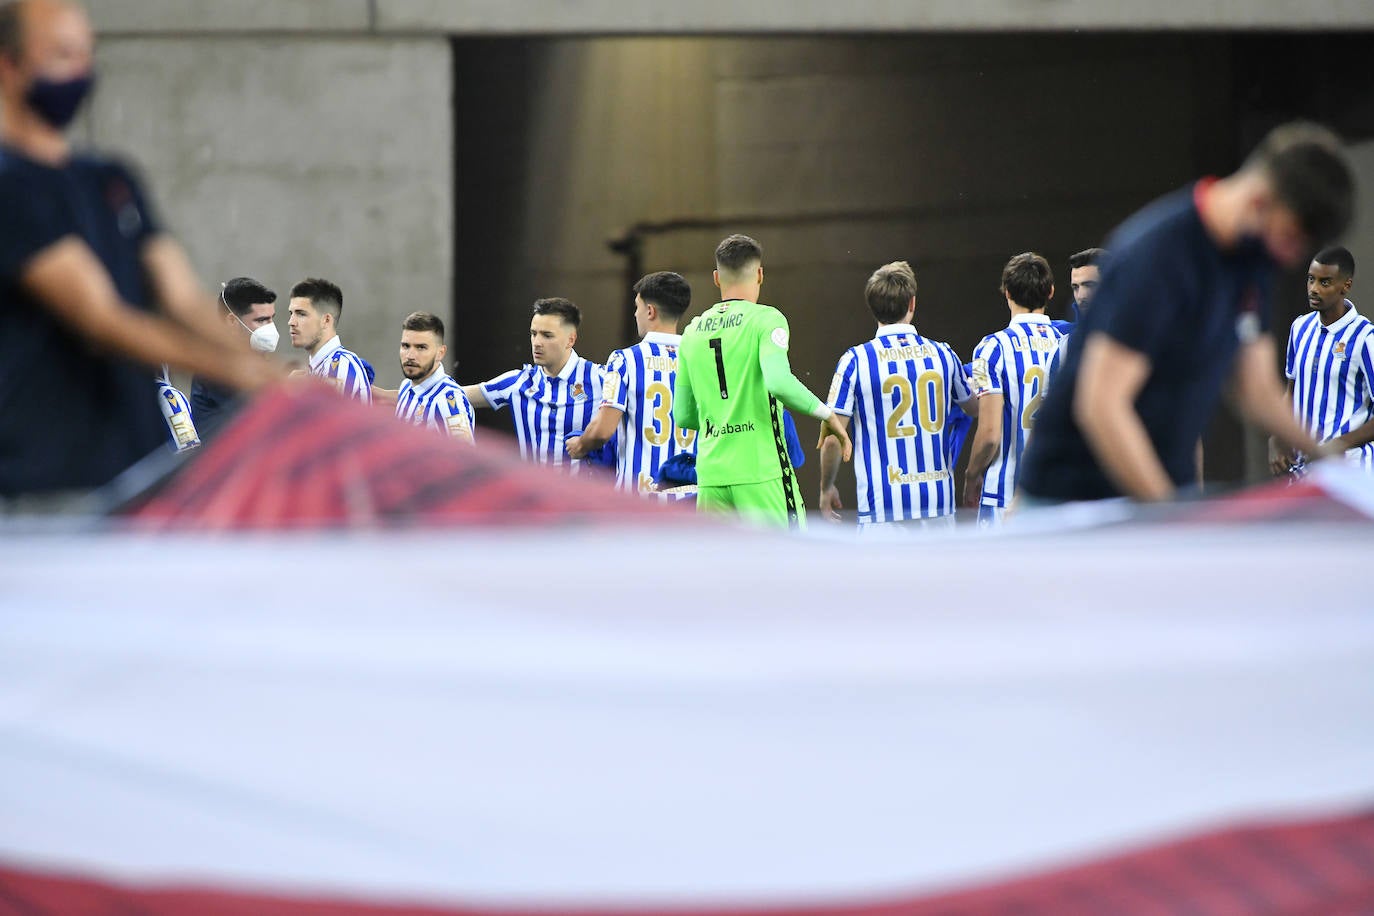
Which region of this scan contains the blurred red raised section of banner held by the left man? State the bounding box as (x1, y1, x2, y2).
(129, 383, 684, 530)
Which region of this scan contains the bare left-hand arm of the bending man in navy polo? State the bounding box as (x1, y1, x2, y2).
(1073, 331, 1173, 501)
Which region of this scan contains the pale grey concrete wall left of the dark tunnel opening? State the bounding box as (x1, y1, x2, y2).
(87, 35, 453, 386)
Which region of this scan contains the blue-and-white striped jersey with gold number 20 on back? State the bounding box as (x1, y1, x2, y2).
(829, 324, 973, 525)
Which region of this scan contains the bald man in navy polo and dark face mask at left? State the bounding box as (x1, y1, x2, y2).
(0, 0, 276, 508)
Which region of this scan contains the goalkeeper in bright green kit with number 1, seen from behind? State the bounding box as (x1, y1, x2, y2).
(673, 235, 851, 527)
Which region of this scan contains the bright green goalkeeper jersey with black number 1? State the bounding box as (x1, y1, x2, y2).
(673, 299, 823, 486)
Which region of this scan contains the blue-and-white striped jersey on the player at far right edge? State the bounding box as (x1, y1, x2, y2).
(1285, 299, 1374, 470)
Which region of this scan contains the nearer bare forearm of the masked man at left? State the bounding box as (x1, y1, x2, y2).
(19, 235, 279, 391)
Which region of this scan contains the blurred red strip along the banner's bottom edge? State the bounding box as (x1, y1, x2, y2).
(0, 813, 1374, 916)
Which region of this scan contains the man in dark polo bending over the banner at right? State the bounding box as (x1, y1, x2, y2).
(1020, 124, 1353, 505)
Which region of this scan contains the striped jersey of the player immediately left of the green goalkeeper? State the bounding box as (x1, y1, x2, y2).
(602, 331, 697, 493)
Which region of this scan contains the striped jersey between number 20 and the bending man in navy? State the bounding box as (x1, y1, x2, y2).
(973, 313, 1065, 508)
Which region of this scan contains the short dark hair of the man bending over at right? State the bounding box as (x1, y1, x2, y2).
(1245, 121, 1355, 244)
